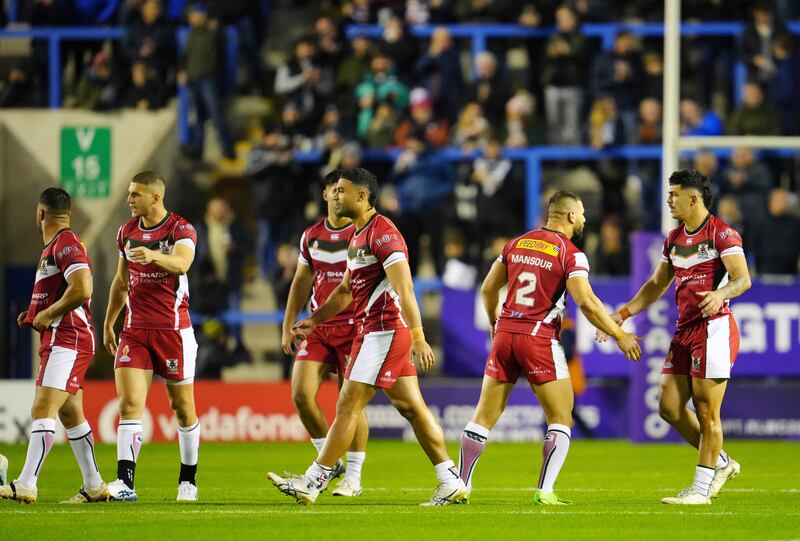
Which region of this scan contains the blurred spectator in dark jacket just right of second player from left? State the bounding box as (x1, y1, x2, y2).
(195, 197, 253, 350)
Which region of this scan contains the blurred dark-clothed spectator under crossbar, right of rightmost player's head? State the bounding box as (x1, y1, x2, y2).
(720, 148, 772, 218)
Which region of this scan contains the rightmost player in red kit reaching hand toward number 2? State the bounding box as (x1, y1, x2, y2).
(598, 170, 750, 505)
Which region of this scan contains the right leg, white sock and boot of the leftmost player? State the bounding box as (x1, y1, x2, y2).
(58, 389, 109, 503)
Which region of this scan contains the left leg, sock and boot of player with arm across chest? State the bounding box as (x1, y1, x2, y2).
(109, 368, 153, 501)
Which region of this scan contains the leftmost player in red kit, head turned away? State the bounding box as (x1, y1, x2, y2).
(0, 188, 109, 503)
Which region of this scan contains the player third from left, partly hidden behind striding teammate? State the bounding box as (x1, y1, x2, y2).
(281, 169, 369, 496)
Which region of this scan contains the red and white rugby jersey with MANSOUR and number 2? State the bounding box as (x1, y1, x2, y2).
(495, 228, 589, 339)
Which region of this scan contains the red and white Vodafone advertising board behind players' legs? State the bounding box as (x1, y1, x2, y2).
(0, 381, 337, 443)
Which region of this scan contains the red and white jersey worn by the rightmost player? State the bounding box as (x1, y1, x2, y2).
(661, 214, 744, 328)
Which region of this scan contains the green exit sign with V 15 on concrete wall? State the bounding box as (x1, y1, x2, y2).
(61, 126, 111, 198)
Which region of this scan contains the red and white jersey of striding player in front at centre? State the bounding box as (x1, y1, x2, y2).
(347, 213, 408, 334)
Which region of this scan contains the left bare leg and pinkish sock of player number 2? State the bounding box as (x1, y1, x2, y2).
(458, 375, 514, 491)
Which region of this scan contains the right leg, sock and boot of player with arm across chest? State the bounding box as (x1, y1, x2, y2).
(167, 380, 200, 501)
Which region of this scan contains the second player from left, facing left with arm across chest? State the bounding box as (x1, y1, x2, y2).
(103, 171, 200, 501)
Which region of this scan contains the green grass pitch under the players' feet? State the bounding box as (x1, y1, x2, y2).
(0, 440, 800, 541)
